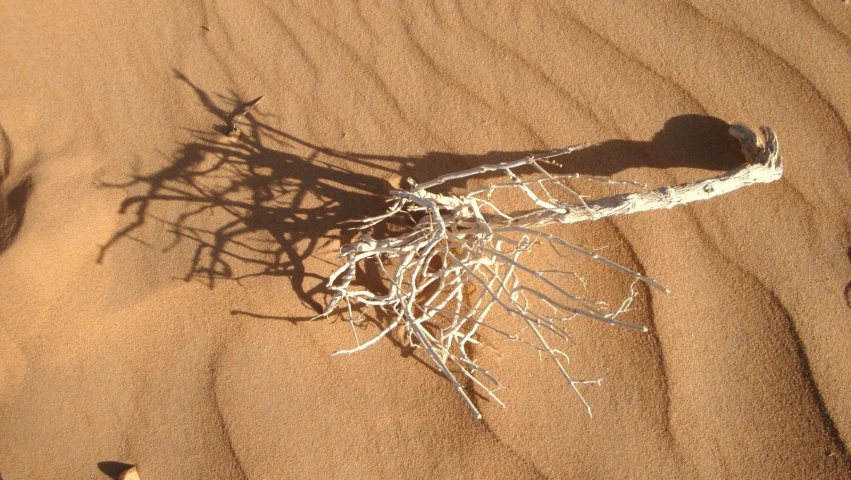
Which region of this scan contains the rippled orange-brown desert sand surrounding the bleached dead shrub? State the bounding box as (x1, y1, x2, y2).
(0, 0, 851, 480)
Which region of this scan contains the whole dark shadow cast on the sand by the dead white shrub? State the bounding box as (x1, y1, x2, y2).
(97, 71, 743, 324)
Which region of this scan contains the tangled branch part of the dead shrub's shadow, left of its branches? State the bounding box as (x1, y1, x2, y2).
(97, 74, 408, 311)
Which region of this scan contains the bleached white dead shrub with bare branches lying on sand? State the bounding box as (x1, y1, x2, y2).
(317, 125, 783, 418)
